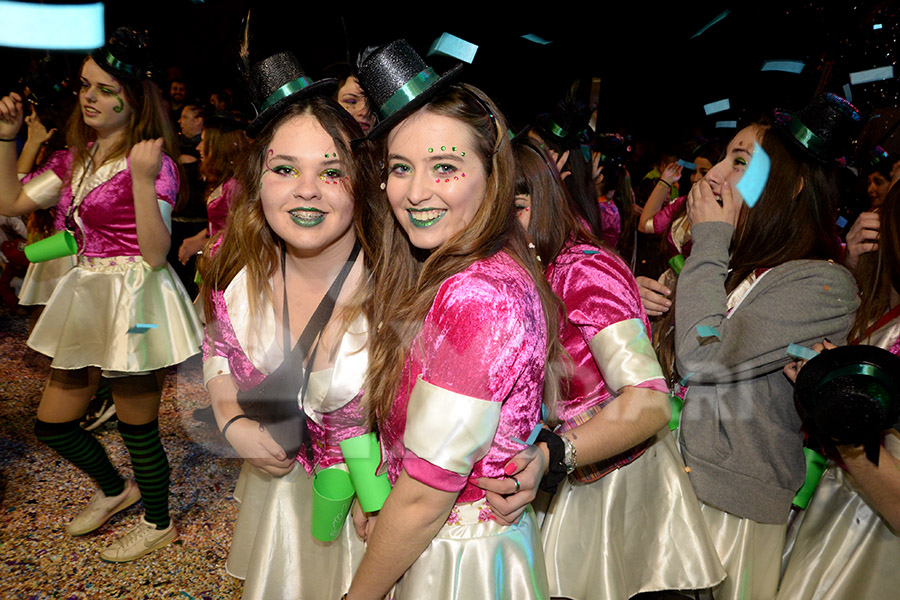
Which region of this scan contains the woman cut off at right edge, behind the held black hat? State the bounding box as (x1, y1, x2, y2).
(778, 184, 900, 600)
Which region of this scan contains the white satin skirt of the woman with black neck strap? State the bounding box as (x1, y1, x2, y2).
(225, 461, 365, 600)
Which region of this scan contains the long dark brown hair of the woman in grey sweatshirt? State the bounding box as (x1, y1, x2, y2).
(655, 122, 840, 381)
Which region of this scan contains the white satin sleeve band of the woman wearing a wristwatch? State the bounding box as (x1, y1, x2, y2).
(589, 319, 663, 394)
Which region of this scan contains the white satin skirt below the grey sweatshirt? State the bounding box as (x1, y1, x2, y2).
(700, 504, 787, 600)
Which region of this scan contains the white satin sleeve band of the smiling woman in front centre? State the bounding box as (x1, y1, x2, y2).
(403, 376, 501, 475)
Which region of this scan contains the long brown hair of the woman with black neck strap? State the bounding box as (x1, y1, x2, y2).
(197, 98, 376, 320)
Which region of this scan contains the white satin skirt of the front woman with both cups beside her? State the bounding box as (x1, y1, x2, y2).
(392, 500, 550, 600)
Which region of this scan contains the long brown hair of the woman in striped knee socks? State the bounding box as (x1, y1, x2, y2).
(66, 57, 184, 179)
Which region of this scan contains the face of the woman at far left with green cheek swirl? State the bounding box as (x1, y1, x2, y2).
(78, 58, 133, 134)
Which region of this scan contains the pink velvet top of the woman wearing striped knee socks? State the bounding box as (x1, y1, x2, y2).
(23, 150, 178, 257)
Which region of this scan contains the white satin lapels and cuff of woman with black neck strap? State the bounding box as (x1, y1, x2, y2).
(220, 269, 369, 425)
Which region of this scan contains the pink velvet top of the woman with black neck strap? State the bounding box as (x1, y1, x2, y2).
(203, 278, 368, 475)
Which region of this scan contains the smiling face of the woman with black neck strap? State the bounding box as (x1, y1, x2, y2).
(260, 114, 355, 257)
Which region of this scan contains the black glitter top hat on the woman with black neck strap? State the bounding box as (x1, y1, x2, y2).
(247, 52, 338, 137)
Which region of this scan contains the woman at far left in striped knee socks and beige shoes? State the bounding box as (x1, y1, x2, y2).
(0, 28, 201, 562)
